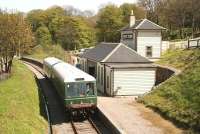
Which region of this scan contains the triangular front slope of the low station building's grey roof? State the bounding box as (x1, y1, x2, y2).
(104, 44, 152, 63)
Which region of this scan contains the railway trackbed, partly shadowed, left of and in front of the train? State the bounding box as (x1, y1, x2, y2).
(23, 59, 107, 134)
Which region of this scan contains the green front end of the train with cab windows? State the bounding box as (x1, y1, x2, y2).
(65, 80, 97, 111)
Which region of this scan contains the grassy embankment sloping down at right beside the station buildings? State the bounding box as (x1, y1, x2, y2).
(139, 49, 200, 131)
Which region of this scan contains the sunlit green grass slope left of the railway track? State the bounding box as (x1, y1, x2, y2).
(0, 60, 48, 134)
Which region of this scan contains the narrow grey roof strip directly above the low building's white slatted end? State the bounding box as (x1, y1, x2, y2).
(106, 63, 156, 68)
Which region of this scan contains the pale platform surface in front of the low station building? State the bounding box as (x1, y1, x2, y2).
(98, 97, 182, 134)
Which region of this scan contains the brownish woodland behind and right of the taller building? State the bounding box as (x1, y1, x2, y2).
(138, 0, 200, 39)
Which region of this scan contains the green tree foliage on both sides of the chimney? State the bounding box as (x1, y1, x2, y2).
(96, 3, 145, 42)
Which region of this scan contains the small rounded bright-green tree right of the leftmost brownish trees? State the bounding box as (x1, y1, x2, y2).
(35, 26, 52, 46)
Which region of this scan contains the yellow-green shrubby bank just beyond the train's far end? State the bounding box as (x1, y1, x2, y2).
(28, 45, 68, 61)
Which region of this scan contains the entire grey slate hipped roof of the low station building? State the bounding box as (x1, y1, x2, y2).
(80, 43, 152, 63)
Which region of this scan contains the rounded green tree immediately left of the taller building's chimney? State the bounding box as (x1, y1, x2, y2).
(96, 5, 123, 42)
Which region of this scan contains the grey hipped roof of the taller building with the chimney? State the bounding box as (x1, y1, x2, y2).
(121, 19, 166, 31)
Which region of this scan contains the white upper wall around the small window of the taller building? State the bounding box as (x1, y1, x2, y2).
(137, 30, 162, 58)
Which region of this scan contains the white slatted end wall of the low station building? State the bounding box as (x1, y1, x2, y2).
(114, 68, 155, 95)
